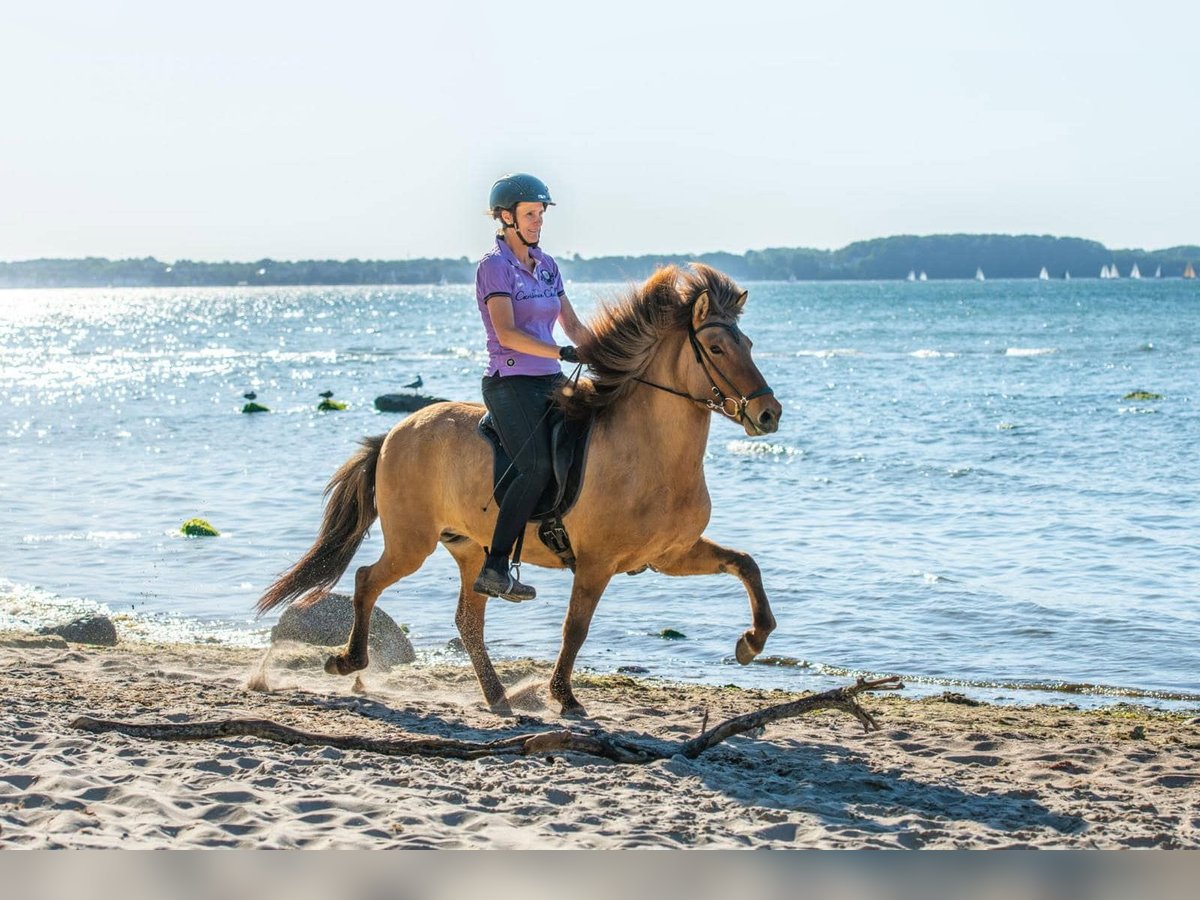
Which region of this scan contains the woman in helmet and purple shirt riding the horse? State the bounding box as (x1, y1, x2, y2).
(475, 174, 589, 601)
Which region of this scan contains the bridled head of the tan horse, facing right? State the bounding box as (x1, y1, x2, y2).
(679, 263, 784, 437)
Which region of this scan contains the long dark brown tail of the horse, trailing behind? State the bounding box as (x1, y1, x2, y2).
(257, 434, 388, 614)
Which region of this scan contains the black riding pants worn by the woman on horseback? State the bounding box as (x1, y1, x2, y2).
(484, 374, 565, 557)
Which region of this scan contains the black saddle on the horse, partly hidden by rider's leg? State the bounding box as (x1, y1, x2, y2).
(479, 407, 593, 572)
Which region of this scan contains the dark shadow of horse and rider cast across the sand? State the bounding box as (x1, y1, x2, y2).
(276, 695, 1087, 847)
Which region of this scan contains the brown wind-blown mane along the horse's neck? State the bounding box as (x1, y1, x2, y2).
(559, 263, 745, 418)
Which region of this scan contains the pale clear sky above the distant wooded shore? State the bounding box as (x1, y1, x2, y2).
(0, 0, 1200, 262)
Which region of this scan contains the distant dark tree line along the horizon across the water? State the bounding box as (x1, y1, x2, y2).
(0, 234, 1200, 288)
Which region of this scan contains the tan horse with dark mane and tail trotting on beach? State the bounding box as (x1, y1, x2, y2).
(257, 263, 782, 716)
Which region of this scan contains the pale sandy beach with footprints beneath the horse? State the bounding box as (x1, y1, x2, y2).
(0, 632, 1200, 848)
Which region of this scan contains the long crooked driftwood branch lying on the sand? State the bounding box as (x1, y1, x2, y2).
(71, 677, 901, 763)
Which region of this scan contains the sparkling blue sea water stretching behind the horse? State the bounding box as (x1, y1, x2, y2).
(0, 280, 1200, 708)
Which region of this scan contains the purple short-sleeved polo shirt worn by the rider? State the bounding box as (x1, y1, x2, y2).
(475, 238, 566, 376)
